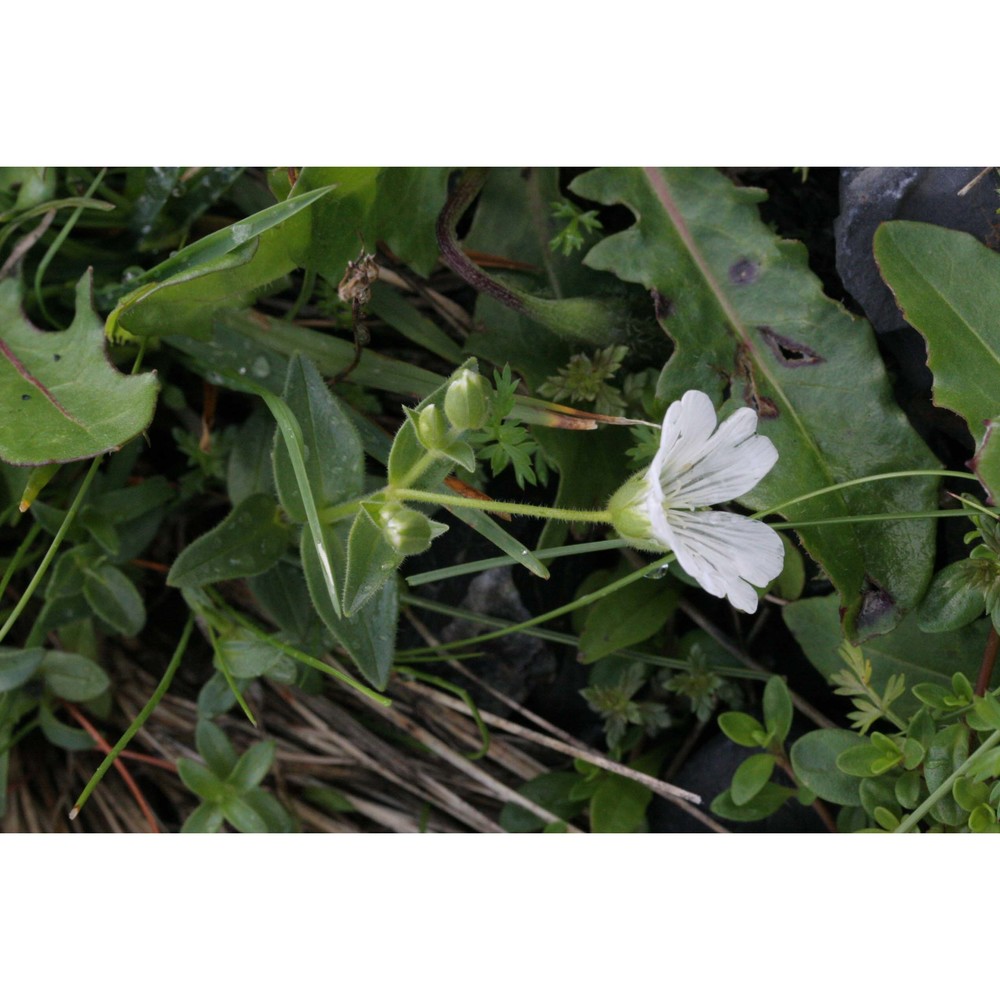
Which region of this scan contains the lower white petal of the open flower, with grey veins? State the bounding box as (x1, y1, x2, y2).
(665, 510, 785, 613)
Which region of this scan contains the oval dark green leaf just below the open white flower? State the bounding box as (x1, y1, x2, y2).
(578, 579, 678, 663)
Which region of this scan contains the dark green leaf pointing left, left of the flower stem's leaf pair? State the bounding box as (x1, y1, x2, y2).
(167, 493, 290, 587)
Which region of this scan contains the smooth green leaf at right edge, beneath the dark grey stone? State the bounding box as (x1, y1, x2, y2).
(875, 222, 1000, 498)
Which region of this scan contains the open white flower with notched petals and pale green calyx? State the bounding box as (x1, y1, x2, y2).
(608, 389, 785, 612)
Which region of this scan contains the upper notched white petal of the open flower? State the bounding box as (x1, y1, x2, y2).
(650, 390, 778, 509)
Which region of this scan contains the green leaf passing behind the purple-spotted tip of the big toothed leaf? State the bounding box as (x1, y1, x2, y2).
(782, 595, 989, 718)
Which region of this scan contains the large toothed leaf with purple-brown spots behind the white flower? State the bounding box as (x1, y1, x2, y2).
(572, 168, 936, 639)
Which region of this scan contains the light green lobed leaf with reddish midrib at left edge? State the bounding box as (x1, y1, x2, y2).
(0, 272, 157, 465)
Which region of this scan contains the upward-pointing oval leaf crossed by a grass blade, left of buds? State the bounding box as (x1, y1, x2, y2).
(274, 355, 364, 524)
